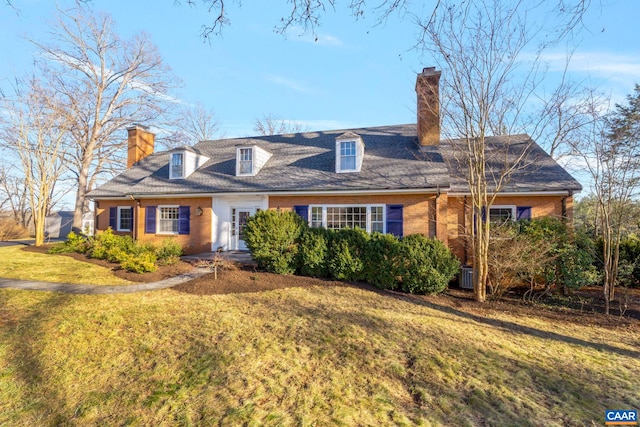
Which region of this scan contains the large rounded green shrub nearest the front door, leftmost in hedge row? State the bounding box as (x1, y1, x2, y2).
(244, 210, 306, 274)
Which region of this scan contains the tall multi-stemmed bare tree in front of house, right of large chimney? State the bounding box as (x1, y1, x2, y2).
(420, 0, 585, 301)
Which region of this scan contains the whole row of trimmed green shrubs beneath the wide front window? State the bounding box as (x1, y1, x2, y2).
(244, 210, 460, 294)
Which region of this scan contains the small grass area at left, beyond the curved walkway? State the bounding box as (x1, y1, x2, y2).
(0, 245, 131, 285)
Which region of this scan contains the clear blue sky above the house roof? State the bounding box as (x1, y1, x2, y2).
(0, 0, 640, 137)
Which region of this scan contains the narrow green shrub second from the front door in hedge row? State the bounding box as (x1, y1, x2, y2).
(298, 228, 330, 277)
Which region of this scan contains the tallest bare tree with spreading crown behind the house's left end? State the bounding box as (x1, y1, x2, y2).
(32, 3, 176, 228)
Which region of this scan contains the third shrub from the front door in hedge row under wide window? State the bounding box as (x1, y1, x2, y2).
(327, 228, 369, 282)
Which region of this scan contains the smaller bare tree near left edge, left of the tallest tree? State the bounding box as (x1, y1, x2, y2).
(0, 78, 67, 246)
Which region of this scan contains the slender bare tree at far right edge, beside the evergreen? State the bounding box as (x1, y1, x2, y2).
(576, 85, 640, 314)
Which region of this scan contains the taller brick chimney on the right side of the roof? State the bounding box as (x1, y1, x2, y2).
(416, 67, 441, 146)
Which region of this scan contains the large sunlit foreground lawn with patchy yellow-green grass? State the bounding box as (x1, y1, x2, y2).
(0, 286, 640, 426)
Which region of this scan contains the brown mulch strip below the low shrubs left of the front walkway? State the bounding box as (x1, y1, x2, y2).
(22, 245, 193, 283)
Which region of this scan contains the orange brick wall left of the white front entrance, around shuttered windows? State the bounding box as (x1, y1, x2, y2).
(95, 197, 212, 254)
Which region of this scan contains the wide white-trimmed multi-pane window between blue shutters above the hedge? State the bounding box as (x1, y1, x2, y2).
(309, 205, 385, 233)
